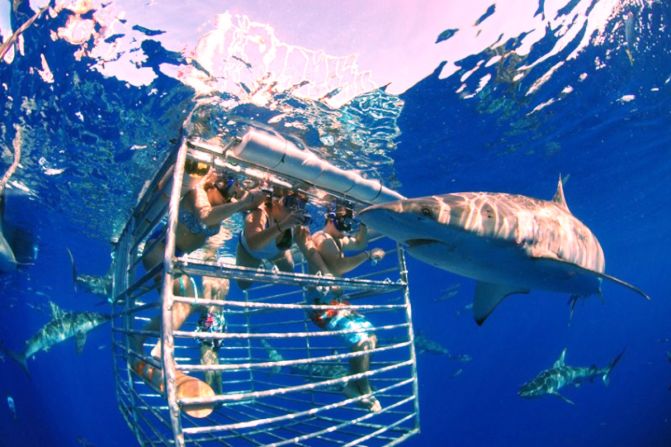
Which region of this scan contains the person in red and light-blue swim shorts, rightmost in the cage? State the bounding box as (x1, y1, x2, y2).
(297, 204, 385, 412)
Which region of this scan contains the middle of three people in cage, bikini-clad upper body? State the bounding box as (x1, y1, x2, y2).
(236, 188, 310, 290)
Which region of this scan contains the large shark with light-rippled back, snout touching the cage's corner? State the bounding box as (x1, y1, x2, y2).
(359, 178, 650, 324)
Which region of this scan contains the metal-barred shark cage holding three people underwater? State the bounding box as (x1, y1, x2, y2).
(112, 128, 419, 446)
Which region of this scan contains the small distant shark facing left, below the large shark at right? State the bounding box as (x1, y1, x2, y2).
(517, 348, 624, 405)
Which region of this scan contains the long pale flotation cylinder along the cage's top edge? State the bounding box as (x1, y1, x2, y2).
(228, 129, 405, 204)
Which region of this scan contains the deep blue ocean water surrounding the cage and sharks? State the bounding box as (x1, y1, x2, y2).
(0, 1, 671, 447)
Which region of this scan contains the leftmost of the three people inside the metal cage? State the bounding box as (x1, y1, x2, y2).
(131, 164, 265, 374)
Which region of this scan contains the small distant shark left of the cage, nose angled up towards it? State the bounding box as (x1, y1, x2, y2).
(7, 301, 110, 373)
